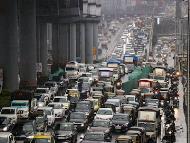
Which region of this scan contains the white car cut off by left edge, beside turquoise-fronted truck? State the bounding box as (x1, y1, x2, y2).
(0, 107, 18, 122)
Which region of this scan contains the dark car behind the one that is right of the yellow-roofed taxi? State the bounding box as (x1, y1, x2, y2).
(69, 112, 89, 131)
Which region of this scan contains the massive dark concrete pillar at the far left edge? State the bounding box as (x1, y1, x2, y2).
(0, 0, 18, 92)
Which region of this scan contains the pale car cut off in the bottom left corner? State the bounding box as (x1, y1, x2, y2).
(0, 132, 16, 143)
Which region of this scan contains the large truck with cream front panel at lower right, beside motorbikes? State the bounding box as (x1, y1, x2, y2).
(137, 106, 161, 142)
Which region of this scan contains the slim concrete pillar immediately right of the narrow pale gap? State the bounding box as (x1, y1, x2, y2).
(52, 23, 59, 66)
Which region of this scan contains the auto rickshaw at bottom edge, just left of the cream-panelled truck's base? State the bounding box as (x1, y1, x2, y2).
(127, 130, 144, 143)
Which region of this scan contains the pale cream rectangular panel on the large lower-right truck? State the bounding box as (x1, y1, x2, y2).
(138, 111, 156, 121)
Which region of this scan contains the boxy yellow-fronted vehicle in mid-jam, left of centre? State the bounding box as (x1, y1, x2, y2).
(67, 89, 80, 103)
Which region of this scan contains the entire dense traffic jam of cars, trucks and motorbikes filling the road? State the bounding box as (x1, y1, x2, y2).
(0, 19, 181, 143)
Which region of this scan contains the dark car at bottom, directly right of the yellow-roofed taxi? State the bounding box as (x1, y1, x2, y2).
(54, 122, 77, 143)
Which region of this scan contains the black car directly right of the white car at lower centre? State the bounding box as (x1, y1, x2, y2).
(112, 113, 132, 132)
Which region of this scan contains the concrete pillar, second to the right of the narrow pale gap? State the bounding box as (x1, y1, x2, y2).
(58, 24, 69, 66)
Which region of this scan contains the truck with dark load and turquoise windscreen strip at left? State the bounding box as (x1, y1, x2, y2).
(11, 90, 37, 118)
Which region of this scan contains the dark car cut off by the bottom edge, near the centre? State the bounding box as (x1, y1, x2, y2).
(80, 132, 112, 143)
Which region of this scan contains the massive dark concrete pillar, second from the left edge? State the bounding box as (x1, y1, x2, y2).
(19, 0, 37, 88)
